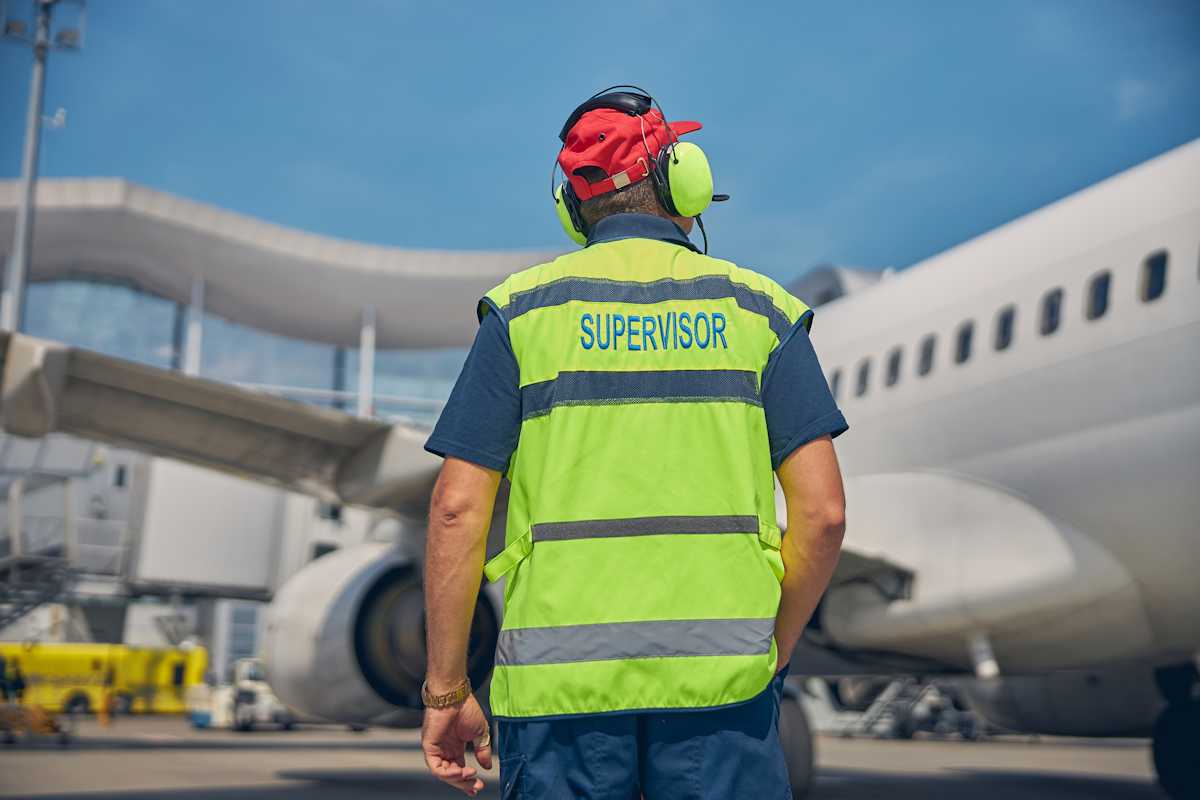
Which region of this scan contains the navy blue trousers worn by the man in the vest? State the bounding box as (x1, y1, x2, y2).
(497, 670, 792, 800)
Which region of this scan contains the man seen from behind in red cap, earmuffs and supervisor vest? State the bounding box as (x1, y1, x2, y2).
(421, 88, 847, 800)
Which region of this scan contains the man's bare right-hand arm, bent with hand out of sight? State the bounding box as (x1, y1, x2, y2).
(775, 437, 846, 667)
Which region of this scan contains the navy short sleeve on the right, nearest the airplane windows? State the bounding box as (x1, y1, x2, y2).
(762, 314, 850, 469)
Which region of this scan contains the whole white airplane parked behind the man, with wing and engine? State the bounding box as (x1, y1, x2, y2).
(0, 140, 1200, 798)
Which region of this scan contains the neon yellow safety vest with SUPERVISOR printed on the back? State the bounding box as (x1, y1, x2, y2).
(481, 239, 809, 717)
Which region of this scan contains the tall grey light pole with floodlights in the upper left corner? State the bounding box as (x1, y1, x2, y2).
(0, 0, 85, 331)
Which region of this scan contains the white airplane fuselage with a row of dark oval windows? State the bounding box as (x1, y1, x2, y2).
(814, 143, 1200, 668)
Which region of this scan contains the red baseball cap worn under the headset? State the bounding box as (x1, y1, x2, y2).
(558, 108, 701, 200)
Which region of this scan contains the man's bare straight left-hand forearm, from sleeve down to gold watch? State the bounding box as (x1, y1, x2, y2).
(425, 458, 500, 694)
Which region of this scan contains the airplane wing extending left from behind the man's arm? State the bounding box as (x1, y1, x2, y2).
(0, 333, 439, 515)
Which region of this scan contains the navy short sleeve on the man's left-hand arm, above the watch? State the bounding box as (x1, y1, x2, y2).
(425, 313, 521, 473)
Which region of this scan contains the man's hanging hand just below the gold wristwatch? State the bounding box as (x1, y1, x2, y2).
(421, 694, 492, 798)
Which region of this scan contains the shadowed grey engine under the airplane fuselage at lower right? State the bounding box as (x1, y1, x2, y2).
(961, 664, 1163, 736)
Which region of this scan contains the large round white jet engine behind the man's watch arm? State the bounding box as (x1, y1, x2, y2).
(264, 543, 499, 723)
